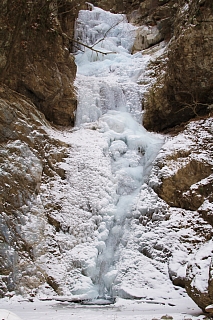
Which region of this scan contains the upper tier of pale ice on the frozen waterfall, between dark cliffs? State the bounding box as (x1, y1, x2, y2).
(76, 8, 162, 126)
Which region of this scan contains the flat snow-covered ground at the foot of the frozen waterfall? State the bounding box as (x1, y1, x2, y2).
(0, 296, 204, 320)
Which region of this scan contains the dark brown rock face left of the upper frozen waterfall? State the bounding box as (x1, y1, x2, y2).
(0, 0, 76, 125)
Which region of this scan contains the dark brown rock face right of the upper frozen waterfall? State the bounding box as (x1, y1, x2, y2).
(144, 1, 213, 131)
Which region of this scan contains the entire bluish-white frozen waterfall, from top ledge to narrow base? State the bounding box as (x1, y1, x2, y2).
(72, 7, 163, 299)
